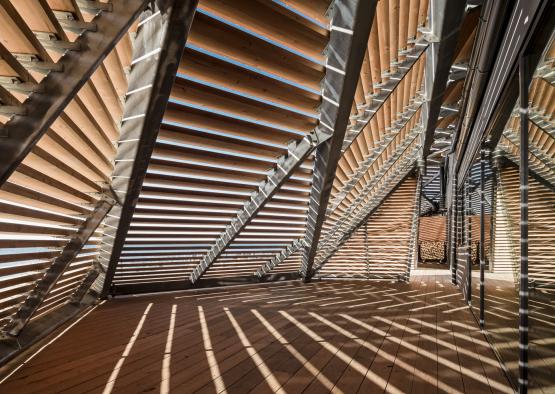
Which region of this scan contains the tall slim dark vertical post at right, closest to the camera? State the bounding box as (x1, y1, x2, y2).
(518, 56, 530, 394)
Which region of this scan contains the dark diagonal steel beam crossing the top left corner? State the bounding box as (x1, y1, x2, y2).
(0, 0, 148, 186)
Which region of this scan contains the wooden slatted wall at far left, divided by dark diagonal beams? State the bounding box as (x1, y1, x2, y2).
(0, 0, 132, 325)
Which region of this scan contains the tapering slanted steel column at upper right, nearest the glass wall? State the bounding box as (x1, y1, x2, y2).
(422, 0, 466, 157)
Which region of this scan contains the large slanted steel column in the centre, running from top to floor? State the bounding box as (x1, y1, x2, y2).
(301, 0, 377, 281)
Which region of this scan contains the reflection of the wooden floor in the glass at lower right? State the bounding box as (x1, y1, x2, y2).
(473, 273, 555, 394)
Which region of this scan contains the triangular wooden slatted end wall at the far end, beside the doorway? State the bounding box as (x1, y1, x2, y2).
(320, 177, 417, 279)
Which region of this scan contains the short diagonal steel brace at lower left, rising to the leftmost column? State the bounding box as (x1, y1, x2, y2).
(3, 197, 115, 337)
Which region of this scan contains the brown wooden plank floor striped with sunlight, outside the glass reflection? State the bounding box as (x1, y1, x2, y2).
(0, 270, 512, 393)
